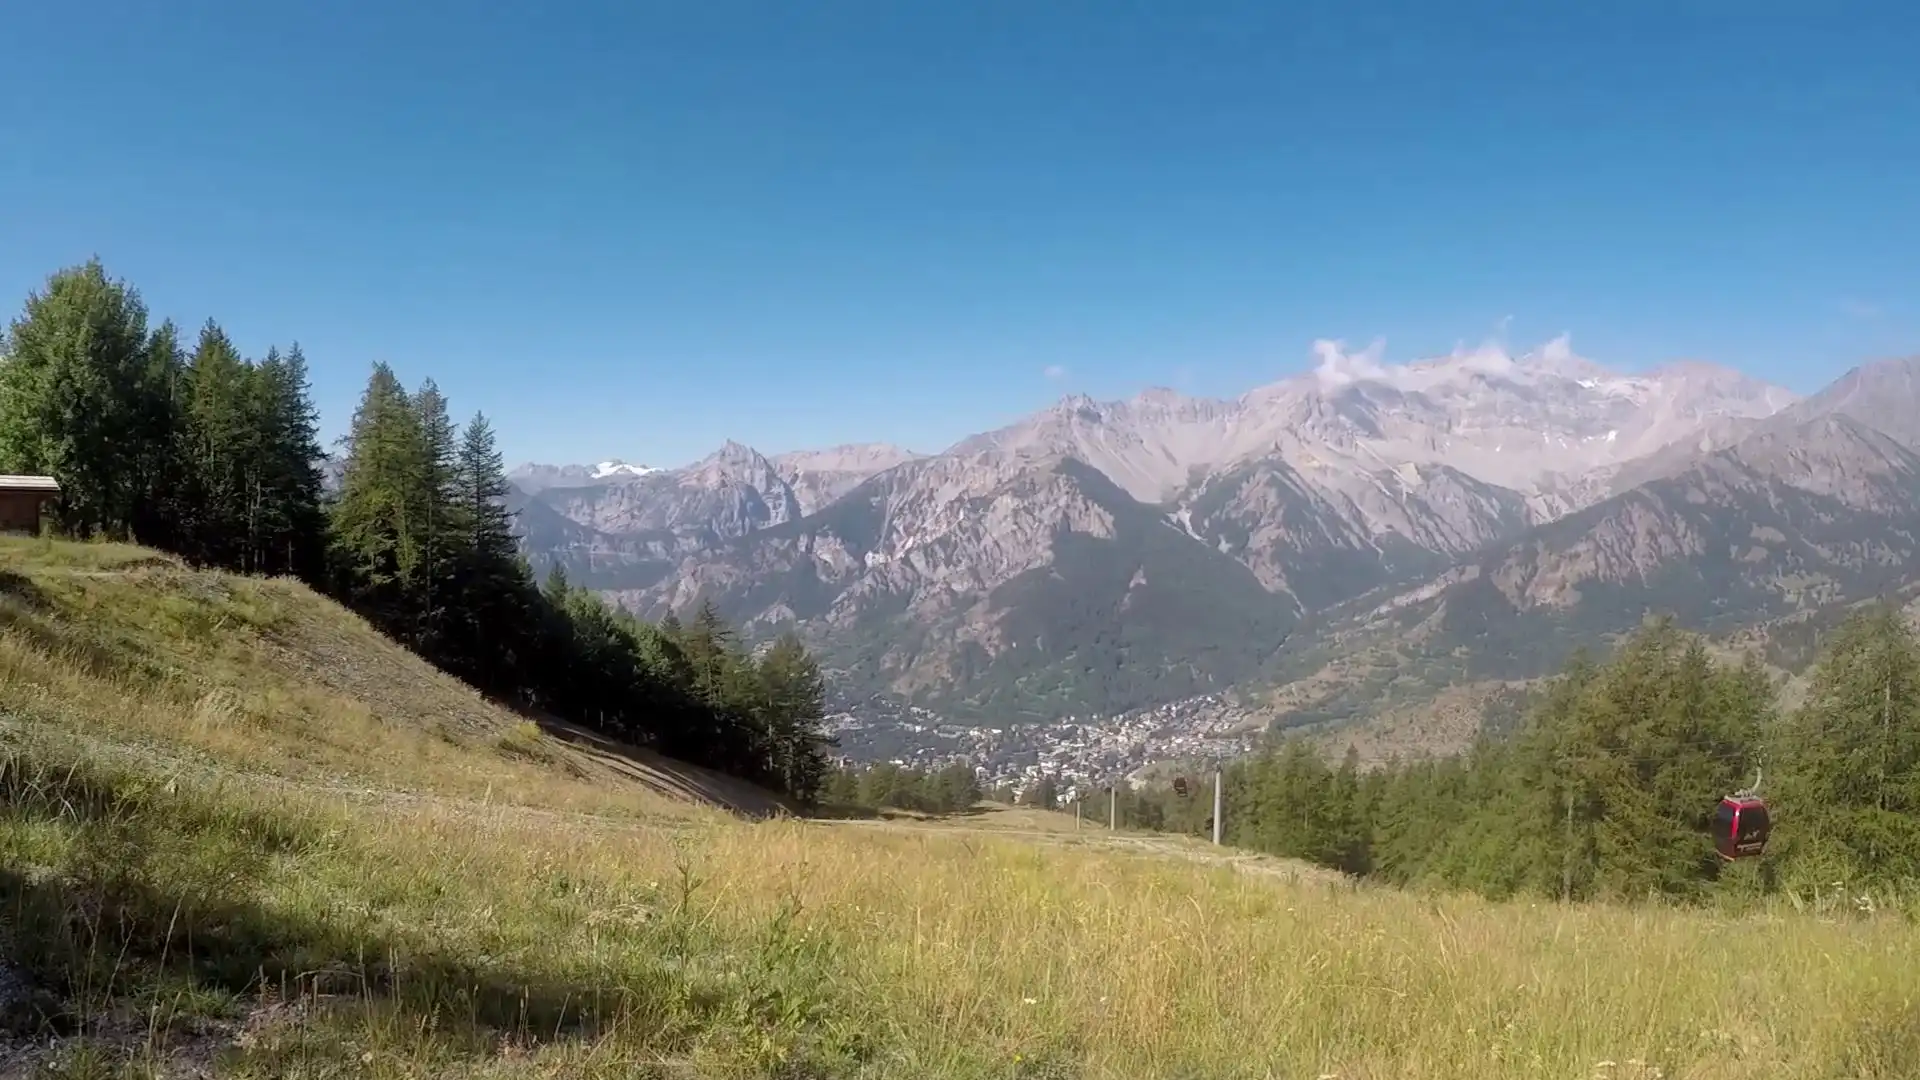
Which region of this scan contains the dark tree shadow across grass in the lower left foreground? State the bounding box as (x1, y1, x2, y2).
(0, 753, 737, 1047)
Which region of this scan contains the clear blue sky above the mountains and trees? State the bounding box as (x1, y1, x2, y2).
(0, 0, 1920, 463)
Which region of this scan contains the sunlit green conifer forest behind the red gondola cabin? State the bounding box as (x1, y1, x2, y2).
(1087, 605, 1920, 903)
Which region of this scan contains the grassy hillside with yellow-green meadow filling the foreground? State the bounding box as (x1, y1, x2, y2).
(0, 542, 1920, 1080)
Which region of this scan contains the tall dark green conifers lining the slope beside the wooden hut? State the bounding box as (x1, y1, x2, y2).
(0, 259, 829, 805)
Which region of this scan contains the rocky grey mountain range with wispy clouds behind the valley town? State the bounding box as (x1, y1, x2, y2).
(511, 338, 1920, 745)
